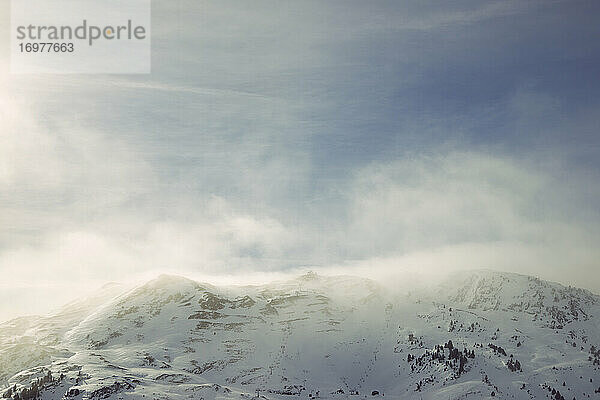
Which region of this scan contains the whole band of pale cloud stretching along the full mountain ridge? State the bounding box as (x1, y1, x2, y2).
(0, 150, 600, 322)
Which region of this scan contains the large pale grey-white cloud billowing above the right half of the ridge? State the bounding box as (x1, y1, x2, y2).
(324, 149, 600, 289)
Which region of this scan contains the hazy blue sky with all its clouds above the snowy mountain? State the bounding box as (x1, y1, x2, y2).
(0, 0, 600, 320)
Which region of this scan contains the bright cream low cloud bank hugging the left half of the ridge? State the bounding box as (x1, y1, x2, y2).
(0, 194, 300, 319)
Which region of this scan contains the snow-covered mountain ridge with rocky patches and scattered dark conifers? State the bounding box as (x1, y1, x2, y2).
(0, 271, 600, 400)
